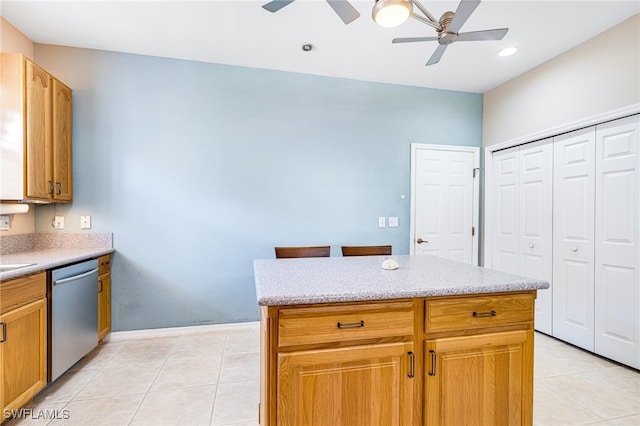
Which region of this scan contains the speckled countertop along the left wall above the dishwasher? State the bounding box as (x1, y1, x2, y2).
(0, 248, 115, 281)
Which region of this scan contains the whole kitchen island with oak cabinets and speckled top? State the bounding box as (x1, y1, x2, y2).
(254, 256, 549, 425)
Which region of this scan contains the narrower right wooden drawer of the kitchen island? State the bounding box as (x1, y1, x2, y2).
(425, 293, 535, 333)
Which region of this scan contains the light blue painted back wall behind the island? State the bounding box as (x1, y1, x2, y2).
(35, 44, 482, 330)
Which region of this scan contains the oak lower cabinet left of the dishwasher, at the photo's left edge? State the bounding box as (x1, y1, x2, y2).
(0, 272, 47, 421)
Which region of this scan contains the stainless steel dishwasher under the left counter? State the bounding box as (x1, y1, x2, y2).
(49, 259, 98, 382)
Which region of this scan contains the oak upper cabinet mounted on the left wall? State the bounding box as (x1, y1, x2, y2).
(0, 53, 73, 203)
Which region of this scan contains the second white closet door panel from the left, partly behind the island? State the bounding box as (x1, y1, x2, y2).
(518, 139, 553, 334)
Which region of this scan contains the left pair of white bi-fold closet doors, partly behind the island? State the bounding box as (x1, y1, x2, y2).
(492, 138, 553, 334)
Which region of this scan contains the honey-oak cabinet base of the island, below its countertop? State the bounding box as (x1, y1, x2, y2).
(259, 291, 536, 426)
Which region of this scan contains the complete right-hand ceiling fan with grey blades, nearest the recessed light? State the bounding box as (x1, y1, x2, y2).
(384, 0, 509, 65)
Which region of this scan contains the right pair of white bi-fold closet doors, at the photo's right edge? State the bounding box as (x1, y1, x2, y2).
(552, 115, 640, 368)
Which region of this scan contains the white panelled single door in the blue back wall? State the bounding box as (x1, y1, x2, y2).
(411, 144, 479, 264)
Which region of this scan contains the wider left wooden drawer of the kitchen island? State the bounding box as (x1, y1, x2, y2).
(278, 301, 414, 346)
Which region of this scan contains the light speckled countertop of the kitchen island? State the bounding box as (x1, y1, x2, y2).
(253, 255, 549, 306)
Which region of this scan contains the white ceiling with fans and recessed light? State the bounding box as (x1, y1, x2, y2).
(0, 0, 640, 93)
